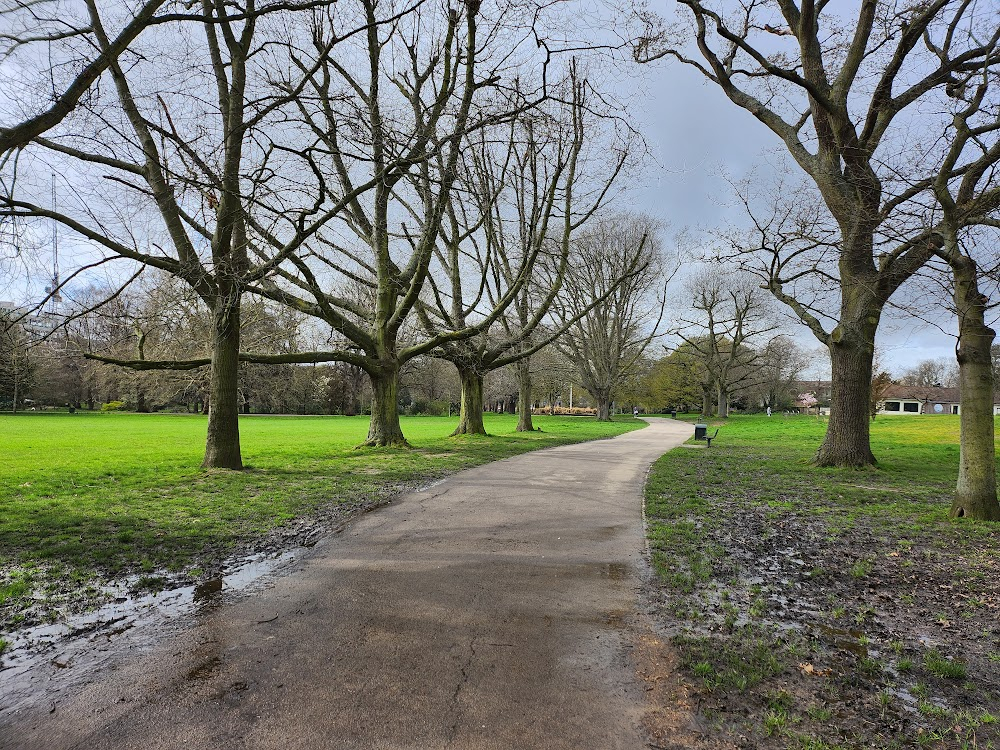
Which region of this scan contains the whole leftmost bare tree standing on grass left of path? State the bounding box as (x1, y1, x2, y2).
(0, 0, 370, 469)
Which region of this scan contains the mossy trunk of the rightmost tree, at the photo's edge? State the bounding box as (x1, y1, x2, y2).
(948, 253, 1000, 521)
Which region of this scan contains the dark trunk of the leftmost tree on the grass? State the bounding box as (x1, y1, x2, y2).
(202, 299, 243, 470)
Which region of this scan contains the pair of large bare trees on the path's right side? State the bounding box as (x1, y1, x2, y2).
(636, 0, 1000, 520)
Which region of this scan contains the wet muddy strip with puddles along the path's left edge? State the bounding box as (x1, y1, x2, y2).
(0, 483, 423, 720)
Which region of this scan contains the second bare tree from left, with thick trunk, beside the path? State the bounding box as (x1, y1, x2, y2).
(242, 0, 568, 446)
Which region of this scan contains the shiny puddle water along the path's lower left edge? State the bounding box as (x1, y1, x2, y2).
(0, 547, 306, 720)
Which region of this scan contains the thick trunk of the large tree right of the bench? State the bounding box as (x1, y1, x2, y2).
(815, 324, 880, 467)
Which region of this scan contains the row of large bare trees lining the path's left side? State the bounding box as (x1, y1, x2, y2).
(0, 0, 659, 469)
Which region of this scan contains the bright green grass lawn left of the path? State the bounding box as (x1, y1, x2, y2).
(0, 413, 643, 627)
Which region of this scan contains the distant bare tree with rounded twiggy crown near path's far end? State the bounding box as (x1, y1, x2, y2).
(552, 214, 673, 421)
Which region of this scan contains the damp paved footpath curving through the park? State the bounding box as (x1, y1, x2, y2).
(0, 419, 692, 750)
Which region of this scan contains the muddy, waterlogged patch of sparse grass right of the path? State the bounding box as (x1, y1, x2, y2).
(640, 446, 1000, 750)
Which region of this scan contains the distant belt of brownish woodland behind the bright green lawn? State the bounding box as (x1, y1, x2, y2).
(0, 276, 608, 420)
